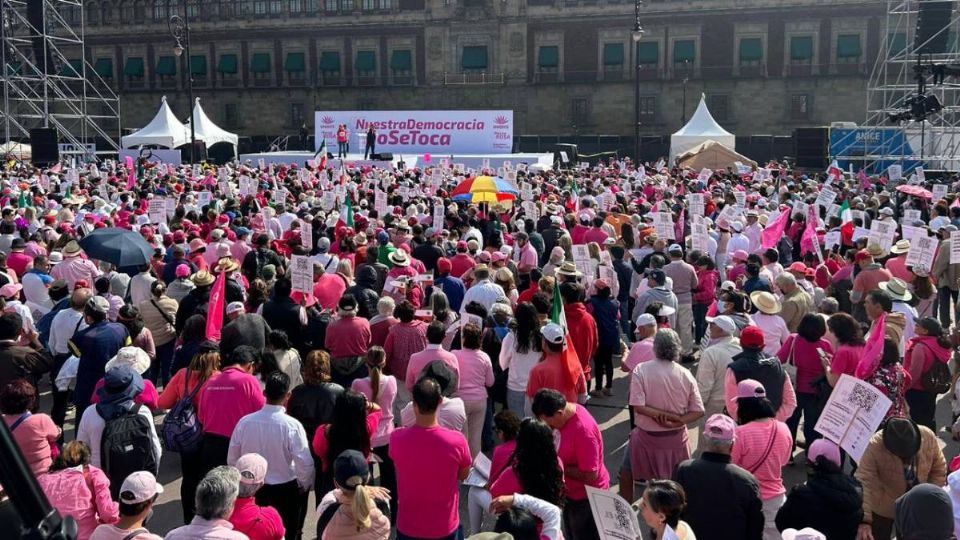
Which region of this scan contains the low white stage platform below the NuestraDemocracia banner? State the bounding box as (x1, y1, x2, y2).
(240, 151, 553, 169)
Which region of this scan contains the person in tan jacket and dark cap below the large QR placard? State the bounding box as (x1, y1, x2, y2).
(855, 416, 947, 540)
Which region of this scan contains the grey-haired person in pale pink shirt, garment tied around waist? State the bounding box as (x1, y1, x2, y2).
(621, 328, 704, 502)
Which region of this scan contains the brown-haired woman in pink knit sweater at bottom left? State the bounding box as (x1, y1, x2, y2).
(37, 441, 120, 540)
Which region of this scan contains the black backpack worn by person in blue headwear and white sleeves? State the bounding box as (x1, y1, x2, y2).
(97, 403, 160, 501)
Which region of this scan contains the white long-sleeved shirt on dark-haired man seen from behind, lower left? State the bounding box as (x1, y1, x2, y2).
(227, 403, 314, 489)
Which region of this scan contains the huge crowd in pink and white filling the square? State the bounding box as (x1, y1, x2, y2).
(0, 153, 960, 540)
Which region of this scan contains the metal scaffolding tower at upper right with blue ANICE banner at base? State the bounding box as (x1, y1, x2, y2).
(844, 0, 960, 174)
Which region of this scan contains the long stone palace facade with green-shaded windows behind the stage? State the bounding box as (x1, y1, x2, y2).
(69, 0, 902, 148)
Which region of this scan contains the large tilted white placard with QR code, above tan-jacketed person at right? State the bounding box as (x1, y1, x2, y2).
(814, 375, 893, 463)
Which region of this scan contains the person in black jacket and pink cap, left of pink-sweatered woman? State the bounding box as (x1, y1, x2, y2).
(673, 414, 764, 540)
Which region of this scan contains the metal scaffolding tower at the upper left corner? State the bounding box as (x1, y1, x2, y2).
(0, 0, 120, 160)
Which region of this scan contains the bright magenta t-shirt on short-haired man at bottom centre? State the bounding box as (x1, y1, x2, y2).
(390, 426, 468, 538)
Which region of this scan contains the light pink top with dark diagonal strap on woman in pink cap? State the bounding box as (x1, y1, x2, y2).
(731, 420, 793, 500)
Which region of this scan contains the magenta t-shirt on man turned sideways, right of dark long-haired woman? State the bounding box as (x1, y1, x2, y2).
(556, 404, 610, 500)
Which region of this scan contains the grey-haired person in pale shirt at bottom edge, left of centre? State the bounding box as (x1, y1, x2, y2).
(165, 466, 247, 540)
